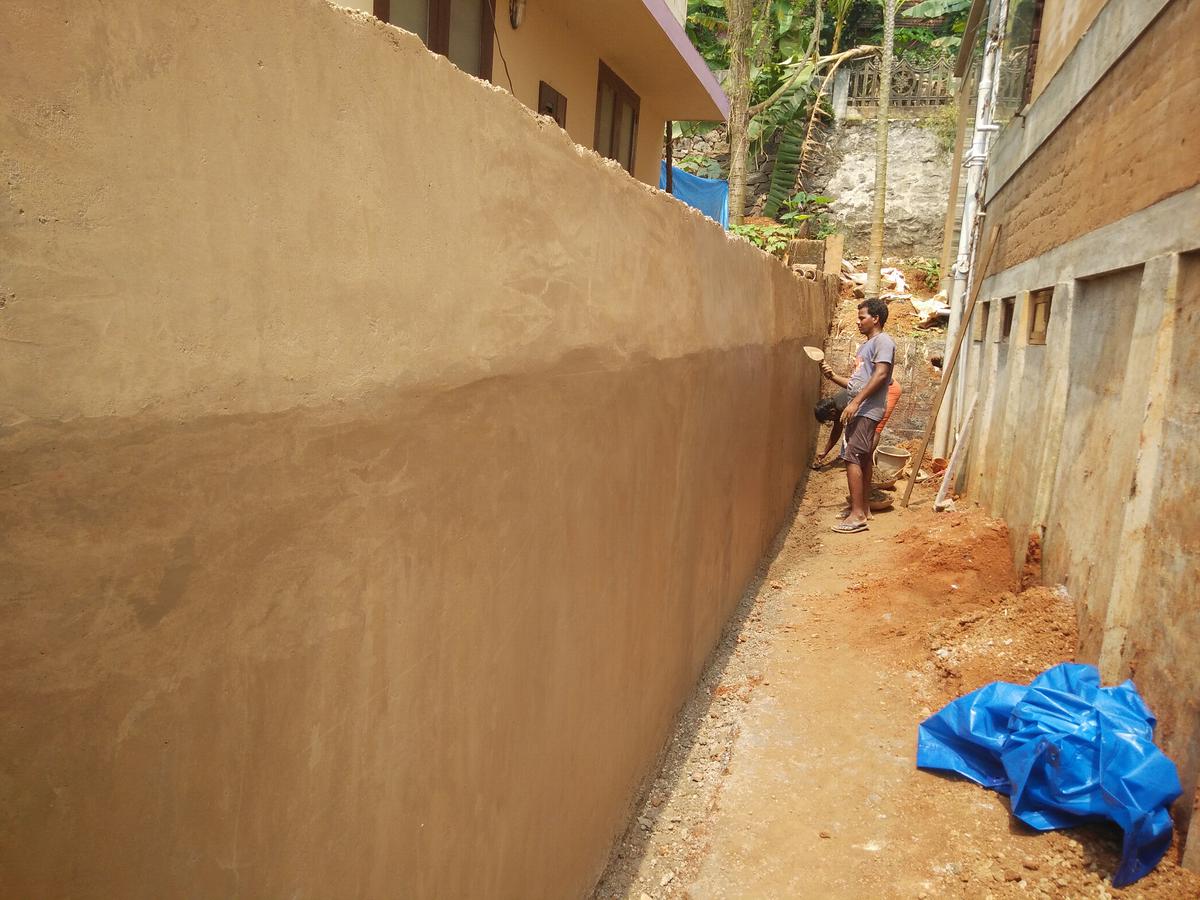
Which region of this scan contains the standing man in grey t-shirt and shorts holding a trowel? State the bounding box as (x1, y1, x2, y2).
(821, 300, 896, 534)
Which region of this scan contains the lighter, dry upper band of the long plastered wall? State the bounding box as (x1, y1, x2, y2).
(0, 0, 827, 425)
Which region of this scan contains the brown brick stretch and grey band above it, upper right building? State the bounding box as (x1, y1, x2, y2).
(988, 0, 1200, 271)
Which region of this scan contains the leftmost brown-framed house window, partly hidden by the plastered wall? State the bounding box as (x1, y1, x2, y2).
(373, 0, 496, 79)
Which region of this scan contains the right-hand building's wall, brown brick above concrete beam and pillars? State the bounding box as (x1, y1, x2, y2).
(964, 0, 1200, 869)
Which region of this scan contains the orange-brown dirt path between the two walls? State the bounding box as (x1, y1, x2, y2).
(596, 469, 1200, 900)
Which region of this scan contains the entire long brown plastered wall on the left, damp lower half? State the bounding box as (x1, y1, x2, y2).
(0, 0, 829, 898)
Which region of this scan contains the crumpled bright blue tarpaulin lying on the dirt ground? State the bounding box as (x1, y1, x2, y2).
(917, 662, 1182, 887)
